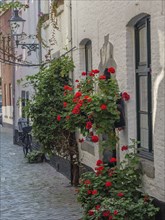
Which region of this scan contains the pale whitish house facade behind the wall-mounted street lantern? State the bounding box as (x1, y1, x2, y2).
(15, 1, 40, 128)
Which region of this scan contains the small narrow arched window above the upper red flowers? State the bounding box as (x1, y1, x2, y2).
(85, 40, 92, 73)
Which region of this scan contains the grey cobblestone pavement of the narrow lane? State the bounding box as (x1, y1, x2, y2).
(0, 128, 81, 220)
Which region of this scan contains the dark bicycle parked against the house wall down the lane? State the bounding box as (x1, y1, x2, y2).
(22, 126, 32, 157)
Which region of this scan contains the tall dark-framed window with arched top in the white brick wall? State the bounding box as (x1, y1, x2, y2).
(135, 16, 153, 159)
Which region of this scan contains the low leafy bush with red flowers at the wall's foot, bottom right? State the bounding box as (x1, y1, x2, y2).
(78, 144, 158, 220)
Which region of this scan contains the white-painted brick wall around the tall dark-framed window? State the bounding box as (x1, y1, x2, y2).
(72, 1, 165, 201)
